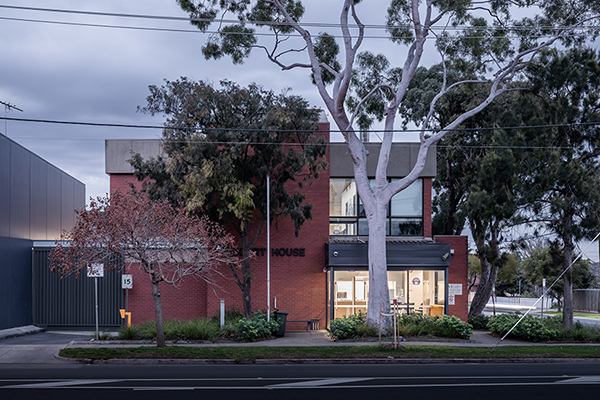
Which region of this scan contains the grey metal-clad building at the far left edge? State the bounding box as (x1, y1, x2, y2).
(0, 135, 85, 329)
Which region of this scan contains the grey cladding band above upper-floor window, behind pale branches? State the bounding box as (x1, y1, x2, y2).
(329, 143, 436, 178)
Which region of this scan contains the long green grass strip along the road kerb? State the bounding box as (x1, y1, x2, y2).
(59, 346, 600, 361)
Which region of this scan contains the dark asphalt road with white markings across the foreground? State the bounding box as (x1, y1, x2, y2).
(0, 362, 600, 400)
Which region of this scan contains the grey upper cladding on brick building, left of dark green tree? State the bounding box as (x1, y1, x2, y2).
(104, 139, 162, 174)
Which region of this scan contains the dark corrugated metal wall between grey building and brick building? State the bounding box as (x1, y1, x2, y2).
(33, 248, 123, 327)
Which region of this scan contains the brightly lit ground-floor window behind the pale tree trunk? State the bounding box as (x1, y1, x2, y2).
(328, 269, 446, 318)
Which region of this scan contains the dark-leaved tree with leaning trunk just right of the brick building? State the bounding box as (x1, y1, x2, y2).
(402, 71, 544, 316)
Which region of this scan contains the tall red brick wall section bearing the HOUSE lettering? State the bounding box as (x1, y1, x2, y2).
(207, 124, 329, 330)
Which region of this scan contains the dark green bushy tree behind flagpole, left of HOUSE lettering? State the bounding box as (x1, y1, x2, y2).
(132, 78, 327, 318)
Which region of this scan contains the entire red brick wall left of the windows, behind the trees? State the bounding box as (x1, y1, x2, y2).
(110, 124, 329, 330)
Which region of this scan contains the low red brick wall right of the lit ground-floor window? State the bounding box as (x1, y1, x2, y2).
(434, 236, 469, 322)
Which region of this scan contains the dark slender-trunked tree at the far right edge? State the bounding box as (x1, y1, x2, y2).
(527, 48, 600, 328)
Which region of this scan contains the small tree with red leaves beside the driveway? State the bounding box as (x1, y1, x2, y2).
(50, 191, 239, 347)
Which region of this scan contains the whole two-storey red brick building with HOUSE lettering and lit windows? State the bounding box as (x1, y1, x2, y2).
(106, 114, 467, 330)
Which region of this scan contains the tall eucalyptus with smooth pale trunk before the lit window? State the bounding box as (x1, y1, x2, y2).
(177, 0, 600, 325)
